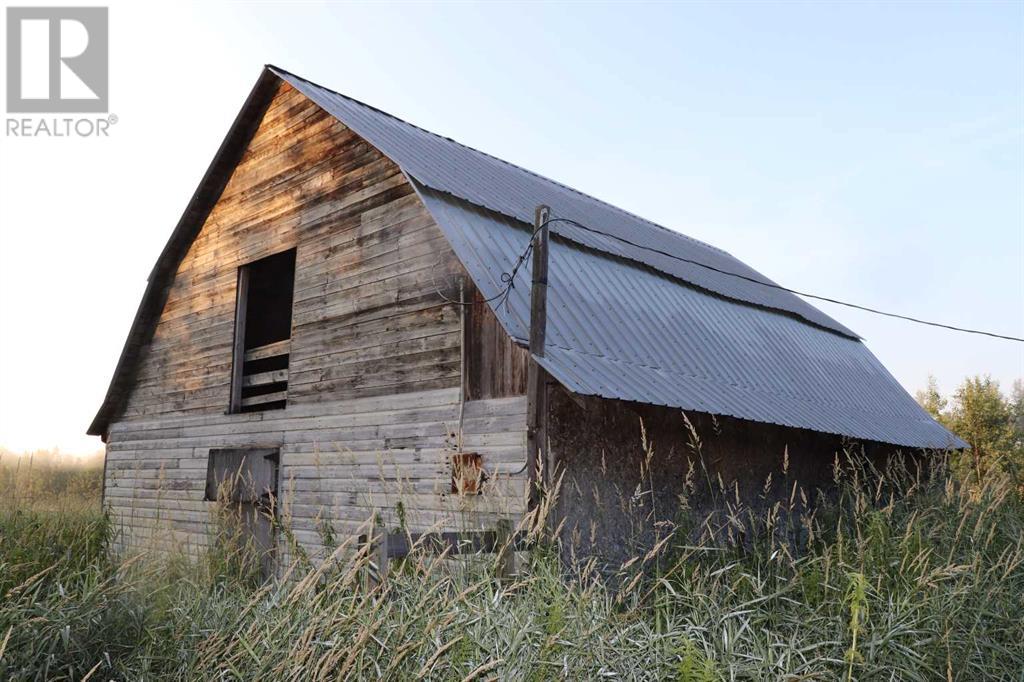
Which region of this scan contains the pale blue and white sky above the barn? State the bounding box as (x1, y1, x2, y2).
(0, 2, 1024, 450)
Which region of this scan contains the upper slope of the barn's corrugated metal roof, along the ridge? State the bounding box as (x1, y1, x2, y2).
(269, 67, 856, 337)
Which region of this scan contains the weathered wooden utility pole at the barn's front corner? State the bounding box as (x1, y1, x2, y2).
(526, 206, 552, 508)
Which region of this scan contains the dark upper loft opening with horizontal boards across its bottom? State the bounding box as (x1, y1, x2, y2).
(230, 249, 295, 412)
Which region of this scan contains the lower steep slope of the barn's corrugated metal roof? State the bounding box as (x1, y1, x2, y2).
(418, 186, 966, 447)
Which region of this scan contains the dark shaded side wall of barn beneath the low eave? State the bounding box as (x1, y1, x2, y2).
(548, 387, 909, 568)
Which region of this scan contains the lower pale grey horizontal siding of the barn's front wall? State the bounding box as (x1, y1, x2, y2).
(106, 389, 525, 551)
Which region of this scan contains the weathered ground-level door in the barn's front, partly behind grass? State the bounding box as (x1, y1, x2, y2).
(206, 447, 280, 580)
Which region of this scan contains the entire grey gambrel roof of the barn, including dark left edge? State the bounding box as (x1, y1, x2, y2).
(89, 67, 966, 449)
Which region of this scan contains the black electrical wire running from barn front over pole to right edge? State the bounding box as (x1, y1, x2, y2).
(437, 218, 1024, 343)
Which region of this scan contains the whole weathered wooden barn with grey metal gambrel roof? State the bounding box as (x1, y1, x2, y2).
(89, 67, 963, 569)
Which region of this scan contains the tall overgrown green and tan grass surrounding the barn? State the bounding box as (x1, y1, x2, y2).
(0, 448, 1024, 680)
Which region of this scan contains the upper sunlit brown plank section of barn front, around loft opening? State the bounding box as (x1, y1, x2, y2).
(116, 84, 460, 418)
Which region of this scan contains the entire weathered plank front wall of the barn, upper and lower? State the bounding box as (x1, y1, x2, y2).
(105, 80, 525, 550)
